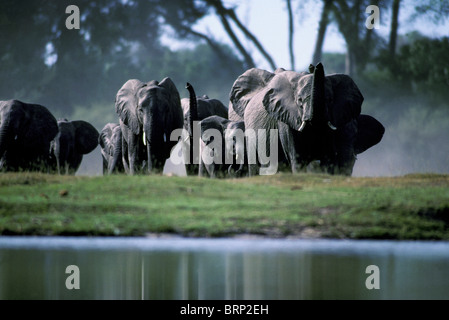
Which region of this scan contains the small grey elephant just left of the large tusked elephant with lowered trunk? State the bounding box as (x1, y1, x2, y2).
(99, 123, 125, 174)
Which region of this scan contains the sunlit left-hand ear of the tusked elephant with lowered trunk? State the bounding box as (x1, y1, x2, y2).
(115, 79, 146, 135)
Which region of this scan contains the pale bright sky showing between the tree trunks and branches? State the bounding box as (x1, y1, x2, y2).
(163, 0, 449, 70)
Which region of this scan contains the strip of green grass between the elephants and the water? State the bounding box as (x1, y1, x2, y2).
(0, 173, 449, 240)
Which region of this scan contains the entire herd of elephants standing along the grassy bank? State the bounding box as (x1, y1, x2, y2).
(0, 63, 385, 177)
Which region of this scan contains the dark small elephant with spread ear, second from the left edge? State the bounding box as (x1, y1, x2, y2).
(50, 119, 99, 174)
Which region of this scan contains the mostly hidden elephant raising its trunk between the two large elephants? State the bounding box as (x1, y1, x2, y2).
(181, 83, 228, 175)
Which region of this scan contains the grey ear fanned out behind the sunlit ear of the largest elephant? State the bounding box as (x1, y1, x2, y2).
(229, 68, 274, 118)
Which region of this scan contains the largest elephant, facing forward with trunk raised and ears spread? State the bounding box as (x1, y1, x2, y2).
(230, 63, 364, 175)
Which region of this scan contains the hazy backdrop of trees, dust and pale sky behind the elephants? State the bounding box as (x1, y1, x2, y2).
(0, 0, 449, 176)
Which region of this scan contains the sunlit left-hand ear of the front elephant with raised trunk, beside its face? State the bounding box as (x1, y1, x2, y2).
(262, 71, 304, 130)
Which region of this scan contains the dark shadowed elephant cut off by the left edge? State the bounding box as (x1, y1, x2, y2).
(0, 100, 58, 172)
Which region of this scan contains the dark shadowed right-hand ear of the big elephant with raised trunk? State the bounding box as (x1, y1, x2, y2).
(326, 74, 364, 128)
